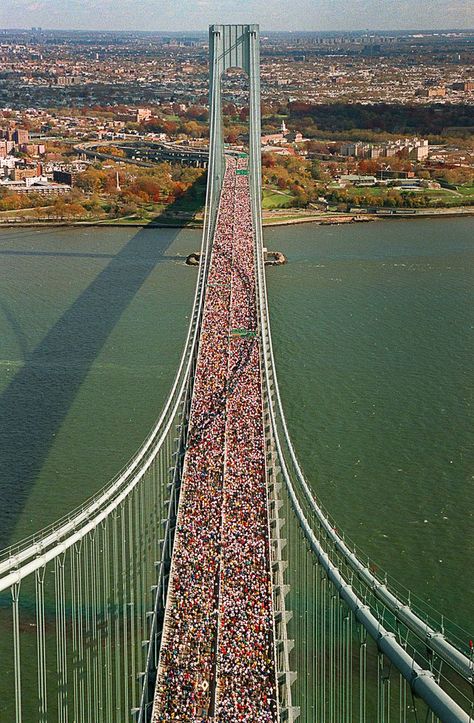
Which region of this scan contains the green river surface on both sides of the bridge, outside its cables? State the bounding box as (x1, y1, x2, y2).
(0, 219, 474, 631)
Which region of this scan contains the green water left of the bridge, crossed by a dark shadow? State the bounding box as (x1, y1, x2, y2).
(0, 229, 199, 539)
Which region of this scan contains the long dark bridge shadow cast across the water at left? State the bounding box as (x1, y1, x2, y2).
(0, 184, 205, 549)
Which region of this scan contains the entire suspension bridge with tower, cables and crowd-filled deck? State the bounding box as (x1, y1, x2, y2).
(0, 25, 474, 723)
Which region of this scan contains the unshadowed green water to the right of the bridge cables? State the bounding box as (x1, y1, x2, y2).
(267, 219, 474, 632)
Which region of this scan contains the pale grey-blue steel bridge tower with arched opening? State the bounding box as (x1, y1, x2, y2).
(207, 25, 262, 237)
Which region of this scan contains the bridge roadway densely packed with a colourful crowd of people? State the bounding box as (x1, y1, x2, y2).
(152, 157, 279, 723)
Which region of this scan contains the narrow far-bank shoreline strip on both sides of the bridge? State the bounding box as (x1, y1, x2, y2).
(0, 206, 474, 230)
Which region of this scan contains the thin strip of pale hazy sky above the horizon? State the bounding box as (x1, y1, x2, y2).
(0, 0, 474, 31)
